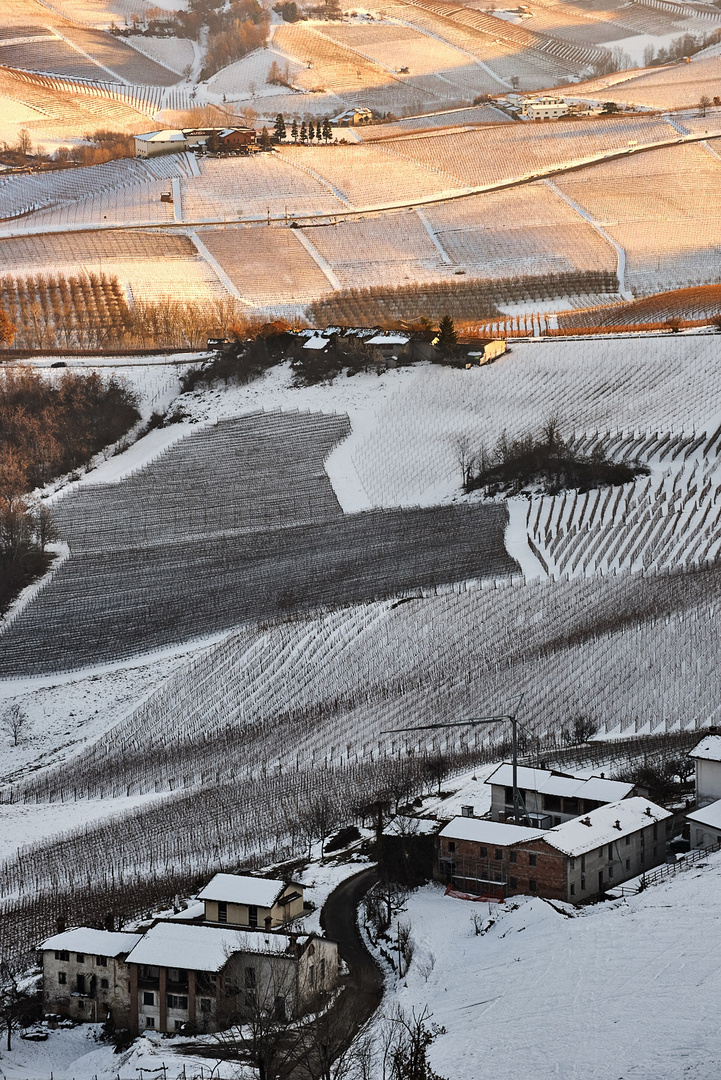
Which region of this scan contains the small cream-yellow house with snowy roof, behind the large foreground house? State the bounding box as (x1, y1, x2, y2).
(198, 874, 303, 930)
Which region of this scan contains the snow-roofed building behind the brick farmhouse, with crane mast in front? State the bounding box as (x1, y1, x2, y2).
(486, 761, 634, 828)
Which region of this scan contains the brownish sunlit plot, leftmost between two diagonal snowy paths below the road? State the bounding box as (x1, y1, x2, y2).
(199, 227, 332, 307)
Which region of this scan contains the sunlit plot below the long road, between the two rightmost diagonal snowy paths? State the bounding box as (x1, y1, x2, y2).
(424, 184, 616, 278)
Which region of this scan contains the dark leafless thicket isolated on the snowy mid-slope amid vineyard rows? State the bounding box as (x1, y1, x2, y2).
(459, 419, 649, 496)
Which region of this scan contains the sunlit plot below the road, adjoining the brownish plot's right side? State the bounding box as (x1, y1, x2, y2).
(307, 211, 449, 288)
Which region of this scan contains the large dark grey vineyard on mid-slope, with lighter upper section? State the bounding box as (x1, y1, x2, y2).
(0, 414, 515, 676)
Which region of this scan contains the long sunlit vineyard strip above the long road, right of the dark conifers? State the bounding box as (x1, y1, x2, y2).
(384, 118, 675, 187)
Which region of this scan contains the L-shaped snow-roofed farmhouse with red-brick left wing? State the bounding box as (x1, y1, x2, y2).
(437, 796, 672, 904)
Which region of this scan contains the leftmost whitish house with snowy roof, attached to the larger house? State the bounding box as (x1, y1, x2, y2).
(40, 927, 141, 1027)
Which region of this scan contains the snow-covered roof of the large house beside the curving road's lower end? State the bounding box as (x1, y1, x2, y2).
(127, 922, 305, 971)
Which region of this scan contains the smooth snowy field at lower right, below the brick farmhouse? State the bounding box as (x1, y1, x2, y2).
(377, 853, 721, 1080)
